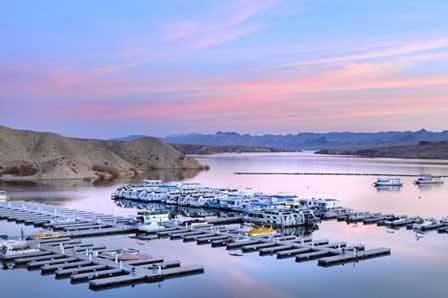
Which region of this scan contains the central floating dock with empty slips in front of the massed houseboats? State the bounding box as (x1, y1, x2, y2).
(137, 221, 391, 267)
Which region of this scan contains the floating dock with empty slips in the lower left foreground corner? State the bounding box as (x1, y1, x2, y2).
(0, 238, 204, 290)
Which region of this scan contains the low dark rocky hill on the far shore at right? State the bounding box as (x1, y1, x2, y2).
(316, 141, 448, 159)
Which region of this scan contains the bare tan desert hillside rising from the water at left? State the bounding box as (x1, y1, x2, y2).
(0, 126, 203, 181)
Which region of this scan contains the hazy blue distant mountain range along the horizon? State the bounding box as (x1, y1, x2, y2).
(161, 129, 448, 151)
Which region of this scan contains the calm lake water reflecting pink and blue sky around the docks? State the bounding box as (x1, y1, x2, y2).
(0, 154, 448, 297)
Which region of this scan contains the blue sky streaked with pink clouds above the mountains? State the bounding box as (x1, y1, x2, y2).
(0, 0, 448, 138)
